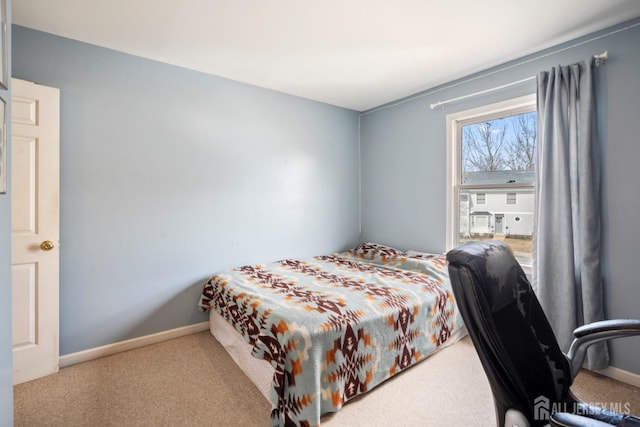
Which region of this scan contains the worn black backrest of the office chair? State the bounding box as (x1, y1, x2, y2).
(447, 241, 573, 426)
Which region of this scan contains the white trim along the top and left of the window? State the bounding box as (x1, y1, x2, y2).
(446, 94, 537, 258)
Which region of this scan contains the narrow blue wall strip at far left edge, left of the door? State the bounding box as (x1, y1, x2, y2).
(0, 0, 13, 427)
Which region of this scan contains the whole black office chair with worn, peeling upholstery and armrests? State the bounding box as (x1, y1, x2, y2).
(447, 241, 640, 427)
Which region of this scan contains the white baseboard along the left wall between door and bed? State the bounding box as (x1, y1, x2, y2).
(59, 322, 209, 368)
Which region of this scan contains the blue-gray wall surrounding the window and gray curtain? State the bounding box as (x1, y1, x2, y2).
(360, 21, 640, 373)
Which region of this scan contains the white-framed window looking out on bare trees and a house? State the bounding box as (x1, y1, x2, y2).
(447, 95, 537, 270)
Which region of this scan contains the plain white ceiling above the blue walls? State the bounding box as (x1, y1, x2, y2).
(12, 0, 640, 111)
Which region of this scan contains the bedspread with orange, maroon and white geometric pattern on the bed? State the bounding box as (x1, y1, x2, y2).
(199, 243, 462, 426)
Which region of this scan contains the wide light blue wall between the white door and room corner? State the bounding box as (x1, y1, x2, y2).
(13, 26, 359, 355)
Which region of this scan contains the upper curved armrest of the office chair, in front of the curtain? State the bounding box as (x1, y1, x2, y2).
(567, 319, 640, 379)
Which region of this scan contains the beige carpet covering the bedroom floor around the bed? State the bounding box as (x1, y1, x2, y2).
(14, 331, 640, 427)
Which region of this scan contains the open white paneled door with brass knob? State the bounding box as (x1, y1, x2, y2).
(11, 79, 60, 384)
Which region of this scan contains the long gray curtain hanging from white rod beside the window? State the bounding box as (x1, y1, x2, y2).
(533, 62, 609, 369)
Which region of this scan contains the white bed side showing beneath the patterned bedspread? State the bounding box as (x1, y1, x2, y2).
(209, 310, 467, 401)
